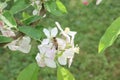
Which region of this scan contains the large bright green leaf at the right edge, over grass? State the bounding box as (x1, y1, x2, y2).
(98, 17, 120, 53)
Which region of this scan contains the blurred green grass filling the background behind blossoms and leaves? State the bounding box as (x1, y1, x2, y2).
(0, 0, 120, 80)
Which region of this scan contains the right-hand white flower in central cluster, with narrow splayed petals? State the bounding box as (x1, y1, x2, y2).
(55, 22, 79, 67)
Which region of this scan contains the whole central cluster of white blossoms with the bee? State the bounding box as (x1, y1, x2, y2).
(36, 22, 79, 68)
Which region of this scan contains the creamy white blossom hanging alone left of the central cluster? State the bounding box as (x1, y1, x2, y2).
(6, 36, 31, 53)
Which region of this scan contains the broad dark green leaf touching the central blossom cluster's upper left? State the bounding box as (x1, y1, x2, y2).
(19, 26, 42, 41)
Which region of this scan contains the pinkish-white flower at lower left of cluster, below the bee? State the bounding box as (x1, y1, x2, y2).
(36, 44, 56, 68)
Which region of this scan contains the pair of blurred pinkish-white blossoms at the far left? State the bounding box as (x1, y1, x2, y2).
(0, 21, 31, 53)
